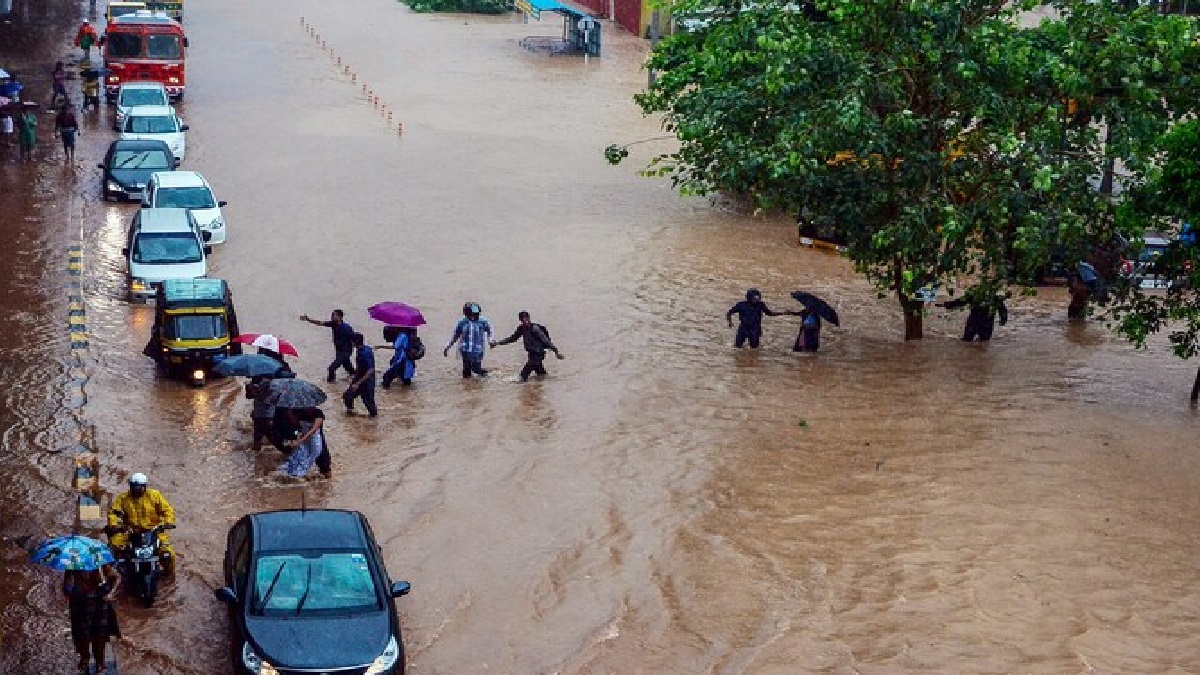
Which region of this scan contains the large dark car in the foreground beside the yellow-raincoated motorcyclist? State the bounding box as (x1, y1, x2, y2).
(216, 509, 409, 675)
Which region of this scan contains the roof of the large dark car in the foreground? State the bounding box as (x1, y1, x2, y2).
(250, 509, 368, 551)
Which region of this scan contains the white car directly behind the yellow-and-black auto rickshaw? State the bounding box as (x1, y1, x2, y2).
(121, 209, 212, 301)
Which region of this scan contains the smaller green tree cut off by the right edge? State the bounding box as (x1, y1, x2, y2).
(1109, 119, 1200, 401)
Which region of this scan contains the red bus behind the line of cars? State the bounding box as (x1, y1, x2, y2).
(102, 11, 187, 103)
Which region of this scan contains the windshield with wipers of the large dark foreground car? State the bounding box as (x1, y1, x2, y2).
(251, 551, 383, 616)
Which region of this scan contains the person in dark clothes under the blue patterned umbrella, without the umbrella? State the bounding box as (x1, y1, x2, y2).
(62, 565, 121, 674)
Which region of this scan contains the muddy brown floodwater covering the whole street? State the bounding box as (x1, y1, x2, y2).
(0, 0, 1200, 674)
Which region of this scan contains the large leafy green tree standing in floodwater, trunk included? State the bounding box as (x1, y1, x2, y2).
(624, 0, 1196, 339)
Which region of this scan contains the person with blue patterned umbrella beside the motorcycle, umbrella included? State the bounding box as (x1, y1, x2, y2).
(29, 534, 121, 674)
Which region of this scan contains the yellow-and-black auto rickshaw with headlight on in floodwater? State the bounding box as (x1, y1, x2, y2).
(143, 279, 241, 387)
